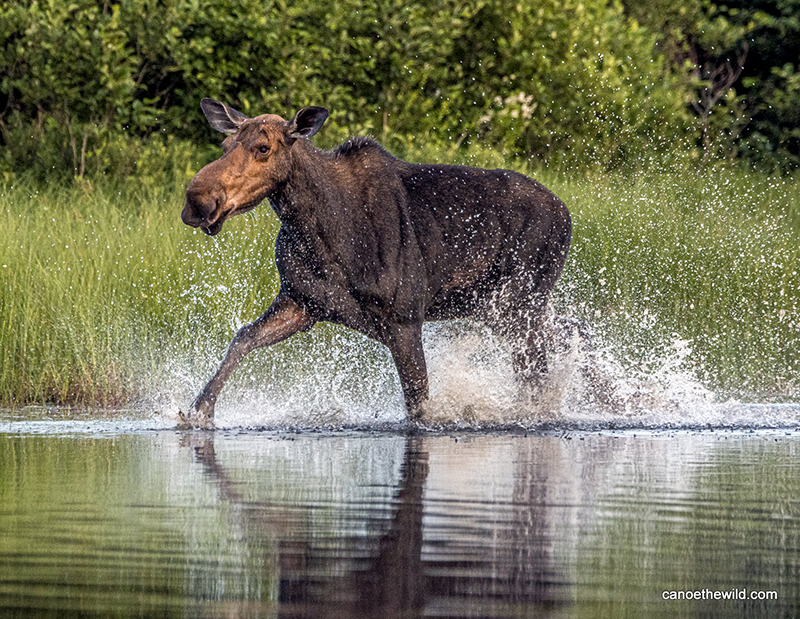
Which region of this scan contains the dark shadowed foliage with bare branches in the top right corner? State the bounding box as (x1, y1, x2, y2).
(624, 0, 800, 172)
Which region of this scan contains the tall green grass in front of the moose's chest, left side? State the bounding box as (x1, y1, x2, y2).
(0, 178, 276, 406)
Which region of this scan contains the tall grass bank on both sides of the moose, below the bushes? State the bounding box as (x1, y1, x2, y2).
(0, 165, 800, 406)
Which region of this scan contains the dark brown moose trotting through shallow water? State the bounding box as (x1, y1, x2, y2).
(180, 99, 572, 427)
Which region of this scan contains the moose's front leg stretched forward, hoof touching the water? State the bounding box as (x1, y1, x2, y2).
(179, 294, 314, 428)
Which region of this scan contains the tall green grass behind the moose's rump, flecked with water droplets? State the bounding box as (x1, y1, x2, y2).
(552, 169, 800, 400)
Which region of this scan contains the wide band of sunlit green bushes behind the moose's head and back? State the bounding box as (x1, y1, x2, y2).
(0, 0, 690, 180)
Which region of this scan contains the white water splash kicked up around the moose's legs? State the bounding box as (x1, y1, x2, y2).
(144, 310, 800, 431)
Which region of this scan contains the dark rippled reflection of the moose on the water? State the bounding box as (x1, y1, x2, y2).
(183, 433, 564, 619)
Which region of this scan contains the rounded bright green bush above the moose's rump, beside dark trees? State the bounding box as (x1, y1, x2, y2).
(468, 1, 690, 167)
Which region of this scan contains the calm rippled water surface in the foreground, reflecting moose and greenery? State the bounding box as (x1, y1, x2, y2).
(0, 424, 800, 617)
